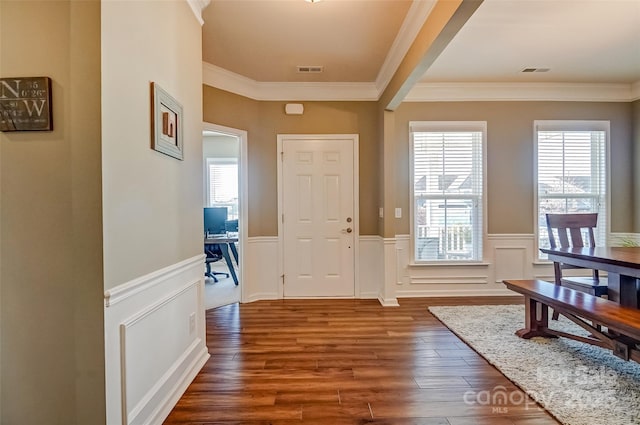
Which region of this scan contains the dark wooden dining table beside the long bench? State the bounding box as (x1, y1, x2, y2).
(540, 247, 640, 308)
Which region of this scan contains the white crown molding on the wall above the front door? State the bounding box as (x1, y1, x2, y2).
(202, 62, 379, 101)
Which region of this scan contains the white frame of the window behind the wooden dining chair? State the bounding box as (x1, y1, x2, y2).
(533, 120, 611, 263)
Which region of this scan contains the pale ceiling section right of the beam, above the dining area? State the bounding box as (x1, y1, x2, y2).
(423, 0, 640, 84)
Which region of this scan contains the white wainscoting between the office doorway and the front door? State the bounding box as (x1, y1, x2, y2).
(242, 236, 282, 302)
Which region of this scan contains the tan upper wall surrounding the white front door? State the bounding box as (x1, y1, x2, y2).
(203, 85, 379, 236)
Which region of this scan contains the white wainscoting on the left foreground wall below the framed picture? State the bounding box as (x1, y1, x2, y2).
(105, 255, 209, 425)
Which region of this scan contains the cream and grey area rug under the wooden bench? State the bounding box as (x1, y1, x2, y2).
(429, 305, 640, 425)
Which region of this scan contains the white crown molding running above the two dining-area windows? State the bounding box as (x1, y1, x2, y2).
(404, 83, 640, 102)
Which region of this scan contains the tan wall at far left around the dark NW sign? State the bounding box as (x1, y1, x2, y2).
(0, 0, 105, 425)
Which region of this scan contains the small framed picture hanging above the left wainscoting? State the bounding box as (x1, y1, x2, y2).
(151, 82, 184, 160)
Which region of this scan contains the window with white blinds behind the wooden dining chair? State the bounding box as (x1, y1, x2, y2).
(535, 121, 609, 259)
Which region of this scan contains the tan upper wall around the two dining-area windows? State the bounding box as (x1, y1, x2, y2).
(395, 102, 634, 234)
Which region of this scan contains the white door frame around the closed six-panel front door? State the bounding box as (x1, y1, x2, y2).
(277, 134, 360, 299)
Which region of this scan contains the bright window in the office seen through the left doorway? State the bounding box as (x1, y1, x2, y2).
(207, 158, 238, 220)
